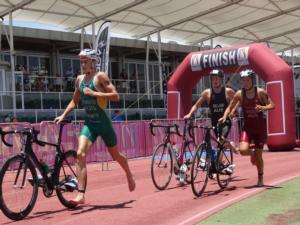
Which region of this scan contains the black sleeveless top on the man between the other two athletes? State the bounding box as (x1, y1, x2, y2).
(209, 87, 229, 126)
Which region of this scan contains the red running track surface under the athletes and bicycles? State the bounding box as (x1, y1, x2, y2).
(0, 151, 300, 225)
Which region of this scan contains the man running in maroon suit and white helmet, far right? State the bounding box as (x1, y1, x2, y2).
(219, 70, 275, 187)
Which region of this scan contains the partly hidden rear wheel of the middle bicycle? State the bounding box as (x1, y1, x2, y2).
(183, 141, 197, 184)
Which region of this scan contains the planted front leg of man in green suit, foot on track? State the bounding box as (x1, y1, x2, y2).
(71, 135, 93, 205)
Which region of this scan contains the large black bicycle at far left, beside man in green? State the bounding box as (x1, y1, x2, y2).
(0, 120, 77, 220)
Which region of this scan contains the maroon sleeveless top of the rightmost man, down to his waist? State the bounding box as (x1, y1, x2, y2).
(242, 87, 265, 129)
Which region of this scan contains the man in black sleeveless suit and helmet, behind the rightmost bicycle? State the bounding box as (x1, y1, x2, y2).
(184, 69, 234, 141)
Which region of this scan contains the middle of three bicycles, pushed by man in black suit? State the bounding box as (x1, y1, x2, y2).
(150, 121, 196, 190)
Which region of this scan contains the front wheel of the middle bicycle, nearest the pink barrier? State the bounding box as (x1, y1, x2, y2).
(151, 143, 173, 190)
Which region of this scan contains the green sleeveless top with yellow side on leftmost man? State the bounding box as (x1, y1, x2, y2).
(79, 78, 108, 122)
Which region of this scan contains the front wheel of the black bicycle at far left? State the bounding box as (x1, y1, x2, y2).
(0, 155, 38, 220)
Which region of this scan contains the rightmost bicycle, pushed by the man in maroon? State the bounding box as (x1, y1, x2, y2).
(191, 125, 233, 197)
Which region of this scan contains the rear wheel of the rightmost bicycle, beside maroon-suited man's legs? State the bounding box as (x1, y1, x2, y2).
(216, 141, 233, 189)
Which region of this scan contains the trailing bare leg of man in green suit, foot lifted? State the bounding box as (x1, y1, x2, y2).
(108, 145, 135, 191)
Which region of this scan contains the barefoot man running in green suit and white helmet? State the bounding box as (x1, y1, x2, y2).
(54, 49, 135, 206)
